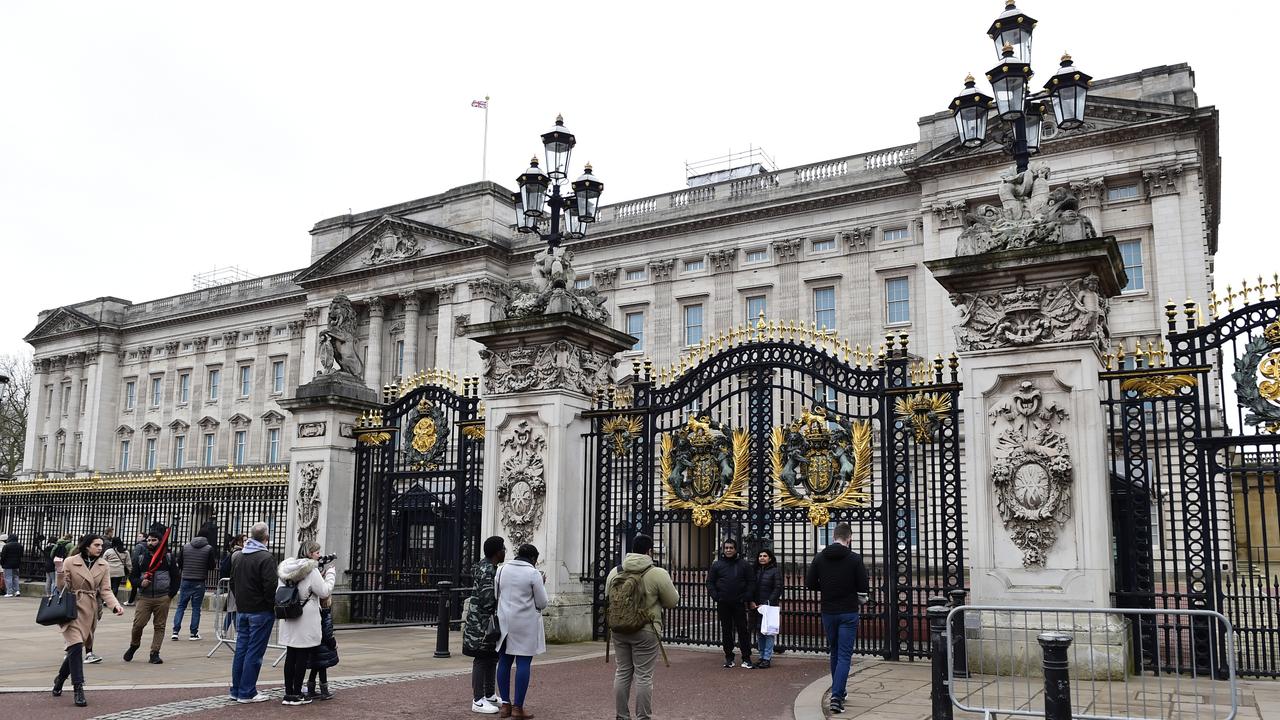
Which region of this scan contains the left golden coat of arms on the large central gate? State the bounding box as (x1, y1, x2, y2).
(662, 415, 751, 528)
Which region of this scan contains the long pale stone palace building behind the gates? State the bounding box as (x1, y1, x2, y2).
(22, 64, 1220, 477)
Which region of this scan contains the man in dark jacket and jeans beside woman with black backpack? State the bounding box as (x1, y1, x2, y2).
(232, 523, 276, 702)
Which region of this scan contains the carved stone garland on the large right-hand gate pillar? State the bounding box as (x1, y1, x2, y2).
(988, 380, 1073, 568)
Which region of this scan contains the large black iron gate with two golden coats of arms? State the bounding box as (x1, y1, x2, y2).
(586, 325, 965, 659)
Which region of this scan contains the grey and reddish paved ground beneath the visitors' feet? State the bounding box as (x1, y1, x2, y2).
(0, 598, 1280, 720)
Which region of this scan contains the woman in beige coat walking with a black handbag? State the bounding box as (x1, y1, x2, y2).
(54, 533, 124, 707)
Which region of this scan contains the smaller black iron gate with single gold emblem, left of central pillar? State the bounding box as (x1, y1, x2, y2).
(351, 372, 484, 623)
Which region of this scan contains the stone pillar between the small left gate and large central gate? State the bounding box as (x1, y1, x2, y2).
(468, 313, 635, 642)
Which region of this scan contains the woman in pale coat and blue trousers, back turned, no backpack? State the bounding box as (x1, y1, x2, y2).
(494, 544, 547, 717)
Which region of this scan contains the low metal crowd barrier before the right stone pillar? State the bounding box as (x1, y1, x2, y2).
(929, 603, 1239, 720)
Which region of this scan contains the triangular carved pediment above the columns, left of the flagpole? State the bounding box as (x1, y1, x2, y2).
(293, 215, 488, 283)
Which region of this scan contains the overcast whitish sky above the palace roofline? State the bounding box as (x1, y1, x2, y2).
(0, 0, 1280, 354)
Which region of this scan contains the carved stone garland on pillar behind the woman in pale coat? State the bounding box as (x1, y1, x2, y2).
(498, 420, 547, 547)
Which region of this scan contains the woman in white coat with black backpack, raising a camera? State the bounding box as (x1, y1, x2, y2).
(275, 541, 337, 705)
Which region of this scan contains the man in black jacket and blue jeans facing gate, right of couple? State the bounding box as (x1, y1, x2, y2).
(804, 523, 870, 715)
